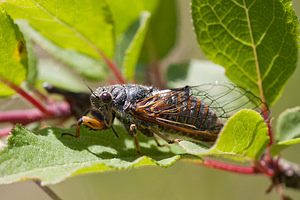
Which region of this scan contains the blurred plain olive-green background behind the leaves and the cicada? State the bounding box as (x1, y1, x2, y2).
(0, 0, 300, 200)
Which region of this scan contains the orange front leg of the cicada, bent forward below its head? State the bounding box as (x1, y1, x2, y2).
(61, 116, 106, 137)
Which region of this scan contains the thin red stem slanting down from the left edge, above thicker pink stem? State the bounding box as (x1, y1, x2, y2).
(0, 78, 53, 116)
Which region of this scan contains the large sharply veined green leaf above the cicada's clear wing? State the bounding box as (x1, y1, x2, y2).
(192, 0, 298, 104)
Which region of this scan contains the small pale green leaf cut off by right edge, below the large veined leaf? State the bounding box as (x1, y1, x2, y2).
(270, 107, 300, 156)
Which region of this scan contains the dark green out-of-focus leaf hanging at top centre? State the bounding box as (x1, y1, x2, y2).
(140, 0, 177, 63)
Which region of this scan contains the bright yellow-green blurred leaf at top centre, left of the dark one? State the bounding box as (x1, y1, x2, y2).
(107, 0, 159, 38)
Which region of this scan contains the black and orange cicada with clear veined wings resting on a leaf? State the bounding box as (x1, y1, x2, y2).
(63, 83, 262, 155)
